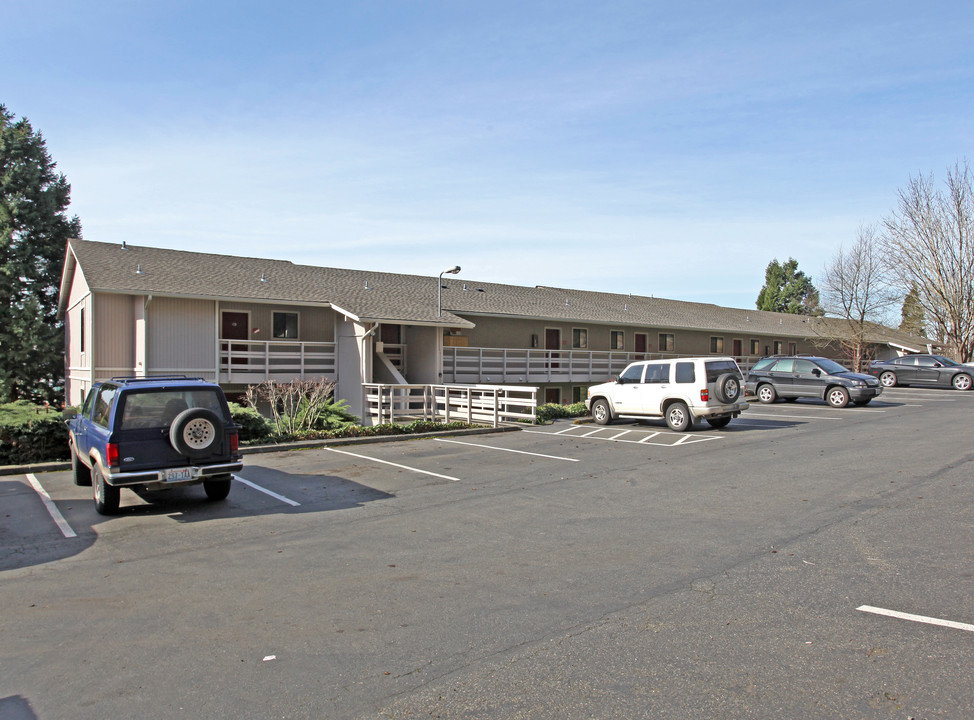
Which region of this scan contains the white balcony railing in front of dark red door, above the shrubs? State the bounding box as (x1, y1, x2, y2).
(219, 340, 338, 384)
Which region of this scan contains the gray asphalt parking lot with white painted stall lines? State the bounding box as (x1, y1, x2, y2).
(0, 388, 974, 719)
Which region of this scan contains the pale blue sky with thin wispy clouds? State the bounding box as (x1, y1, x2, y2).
(0, 0, 974, 308)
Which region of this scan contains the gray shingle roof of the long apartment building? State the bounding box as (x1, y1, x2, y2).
(62, 240, 925, 348)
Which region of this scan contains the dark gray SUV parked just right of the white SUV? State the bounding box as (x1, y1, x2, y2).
(745, 355, 883, 408)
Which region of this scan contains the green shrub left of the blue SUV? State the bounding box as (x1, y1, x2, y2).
(0, 400, 70, 465)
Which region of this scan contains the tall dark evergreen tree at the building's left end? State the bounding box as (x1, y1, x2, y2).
(0, 105, 81, 402)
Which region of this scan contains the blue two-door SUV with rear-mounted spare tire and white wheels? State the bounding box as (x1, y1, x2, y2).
(65, 375, 243, 515)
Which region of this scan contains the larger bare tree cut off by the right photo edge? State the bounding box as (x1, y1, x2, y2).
(883, 162, 974, 362)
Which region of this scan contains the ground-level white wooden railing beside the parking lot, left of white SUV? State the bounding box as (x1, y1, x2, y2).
(363, 383, 538, 427)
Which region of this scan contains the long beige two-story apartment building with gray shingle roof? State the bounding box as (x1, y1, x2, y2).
(60, 240, 923, 415)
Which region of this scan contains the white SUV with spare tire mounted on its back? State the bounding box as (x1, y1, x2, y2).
(585, 357, 748, 432)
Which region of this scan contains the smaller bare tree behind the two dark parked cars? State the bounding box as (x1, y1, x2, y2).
(820, 225, 899, 371)
